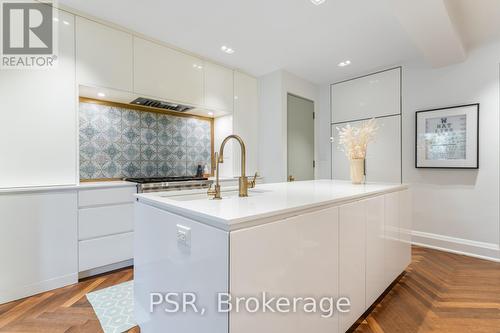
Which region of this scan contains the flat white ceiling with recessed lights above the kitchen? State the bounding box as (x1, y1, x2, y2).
(59, 0, 500, 84)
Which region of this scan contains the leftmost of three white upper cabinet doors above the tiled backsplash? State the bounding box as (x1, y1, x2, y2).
(76, 17, 133, 91)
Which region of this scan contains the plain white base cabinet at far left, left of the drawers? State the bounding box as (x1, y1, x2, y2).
(0, 190, 78, 304)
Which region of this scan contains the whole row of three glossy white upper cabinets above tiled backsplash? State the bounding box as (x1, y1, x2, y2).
(76, 21, 234, 114)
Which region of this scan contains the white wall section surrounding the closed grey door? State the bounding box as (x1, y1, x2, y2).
(259, 70, 320, 183)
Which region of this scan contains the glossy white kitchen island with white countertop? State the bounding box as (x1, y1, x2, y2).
(134, 180, 411, 333)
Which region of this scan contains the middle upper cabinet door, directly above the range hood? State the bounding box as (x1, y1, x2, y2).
(134, 37, 204, 106)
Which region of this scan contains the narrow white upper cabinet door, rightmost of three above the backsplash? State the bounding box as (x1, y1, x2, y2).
(204, 61, 234, 113)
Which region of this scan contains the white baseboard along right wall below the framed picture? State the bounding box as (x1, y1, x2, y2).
(410, 230, 500, 262)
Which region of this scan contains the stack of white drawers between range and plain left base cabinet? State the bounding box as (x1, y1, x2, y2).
(78, 184, 137, 276)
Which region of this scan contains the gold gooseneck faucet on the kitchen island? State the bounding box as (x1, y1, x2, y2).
(208, 134, 258, 200)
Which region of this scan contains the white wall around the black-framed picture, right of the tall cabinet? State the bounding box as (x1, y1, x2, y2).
(318, 40, 500, 260)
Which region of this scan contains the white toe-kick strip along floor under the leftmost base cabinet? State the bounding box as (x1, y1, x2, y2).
(0, 273, 78, 304)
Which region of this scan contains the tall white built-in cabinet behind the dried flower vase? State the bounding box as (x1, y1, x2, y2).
(330, 68, 402, 183)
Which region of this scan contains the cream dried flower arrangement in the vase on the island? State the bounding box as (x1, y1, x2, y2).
(337, 118, 378, 160)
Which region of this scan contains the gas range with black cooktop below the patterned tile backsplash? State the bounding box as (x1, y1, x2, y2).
(125, 176, 213, 193)
